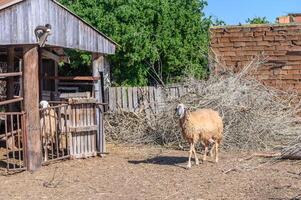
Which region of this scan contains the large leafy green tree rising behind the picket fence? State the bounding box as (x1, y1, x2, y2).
(61, 0, 211, 85)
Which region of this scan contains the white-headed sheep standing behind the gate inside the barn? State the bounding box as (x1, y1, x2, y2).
(40, 100, 57, 161)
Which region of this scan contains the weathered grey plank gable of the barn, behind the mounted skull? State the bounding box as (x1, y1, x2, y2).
(0, 0, 117, 54)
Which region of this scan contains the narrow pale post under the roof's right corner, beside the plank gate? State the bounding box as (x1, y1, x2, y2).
(92, 53, 106, 153)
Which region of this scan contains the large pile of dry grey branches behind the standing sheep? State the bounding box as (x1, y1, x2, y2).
(105, 61, 301, 150)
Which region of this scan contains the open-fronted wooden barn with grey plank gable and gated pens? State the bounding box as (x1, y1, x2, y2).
(0, 0, 116, 171)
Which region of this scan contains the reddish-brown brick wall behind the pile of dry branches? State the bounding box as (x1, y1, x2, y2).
(210, 24, 301, 93)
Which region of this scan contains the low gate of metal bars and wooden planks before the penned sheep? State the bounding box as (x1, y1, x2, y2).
(40, 98, 104, 163)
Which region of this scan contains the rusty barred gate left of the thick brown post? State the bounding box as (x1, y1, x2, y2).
(0, 112, 26, 172)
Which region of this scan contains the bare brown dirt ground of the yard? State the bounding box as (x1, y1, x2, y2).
(0, 145, 301, 200)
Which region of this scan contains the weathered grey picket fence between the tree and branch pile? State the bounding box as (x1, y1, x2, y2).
(107, 85, 189, 112)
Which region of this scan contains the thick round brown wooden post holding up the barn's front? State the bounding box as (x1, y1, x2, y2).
(23, 47, 42, 171)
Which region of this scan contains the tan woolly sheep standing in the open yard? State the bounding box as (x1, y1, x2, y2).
(176, 104, 223, 168)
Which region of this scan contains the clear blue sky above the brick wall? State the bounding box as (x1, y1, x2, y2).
(205, 0, 301, 25)
